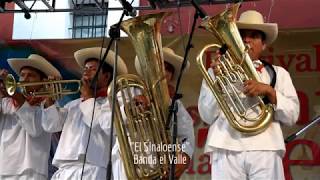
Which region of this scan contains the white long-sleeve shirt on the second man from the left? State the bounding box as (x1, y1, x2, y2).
(43, 98, 111, 168)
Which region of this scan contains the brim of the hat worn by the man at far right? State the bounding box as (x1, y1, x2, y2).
(237, 22, 278, 45)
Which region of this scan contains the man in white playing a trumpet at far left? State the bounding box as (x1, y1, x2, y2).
(0, 54, 61, 180)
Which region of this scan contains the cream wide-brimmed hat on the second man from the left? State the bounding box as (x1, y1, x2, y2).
(74, 47, 128, 74)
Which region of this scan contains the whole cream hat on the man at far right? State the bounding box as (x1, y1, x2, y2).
(237, 10, 278, 45)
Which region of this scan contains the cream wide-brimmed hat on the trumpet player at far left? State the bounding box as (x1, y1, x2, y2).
(8, 54, 61, 77)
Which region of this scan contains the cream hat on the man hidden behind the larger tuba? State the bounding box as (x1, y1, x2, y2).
(134, 47, 190, 82)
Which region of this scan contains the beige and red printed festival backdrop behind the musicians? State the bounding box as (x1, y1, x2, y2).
(0, 29, 320, 179)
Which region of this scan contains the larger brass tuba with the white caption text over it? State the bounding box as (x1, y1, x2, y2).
(108, 13, 170, 179)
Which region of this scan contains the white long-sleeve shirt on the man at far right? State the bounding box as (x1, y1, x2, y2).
(198, 60, 300, 155)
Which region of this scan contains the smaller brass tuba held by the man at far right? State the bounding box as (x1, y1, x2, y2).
(197, 3, 274, 134)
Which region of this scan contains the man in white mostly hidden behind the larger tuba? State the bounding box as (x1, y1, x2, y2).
(112, 47, 195, 180)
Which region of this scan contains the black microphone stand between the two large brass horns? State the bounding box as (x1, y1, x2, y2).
(166, 0, 202, 180)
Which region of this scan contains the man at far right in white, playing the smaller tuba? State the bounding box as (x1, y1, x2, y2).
(198, 10, 299, 180)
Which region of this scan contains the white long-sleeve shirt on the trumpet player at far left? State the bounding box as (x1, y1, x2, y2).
(0, 98, 51, 177)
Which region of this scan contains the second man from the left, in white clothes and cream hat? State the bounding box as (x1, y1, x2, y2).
(43, 47, 127, 180)
